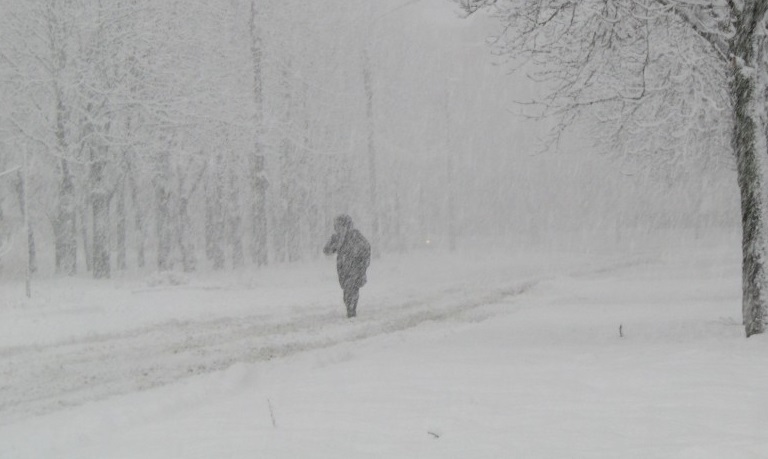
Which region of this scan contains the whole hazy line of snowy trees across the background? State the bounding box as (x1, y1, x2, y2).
(0, 0, 730, 288)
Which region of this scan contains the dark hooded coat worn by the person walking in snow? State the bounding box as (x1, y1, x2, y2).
(323, 215, 371, 290)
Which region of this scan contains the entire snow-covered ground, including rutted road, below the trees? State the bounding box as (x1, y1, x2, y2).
(0, 240, 768, 458)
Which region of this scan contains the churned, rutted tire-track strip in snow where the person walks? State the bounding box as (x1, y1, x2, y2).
(0, 256, 652, 424)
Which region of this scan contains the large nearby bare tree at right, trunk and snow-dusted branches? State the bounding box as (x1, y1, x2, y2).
(458, 0, 768, 336)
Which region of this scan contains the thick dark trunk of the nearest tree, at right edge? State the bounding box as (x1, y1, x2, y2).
(730, 2, 768, 337)
